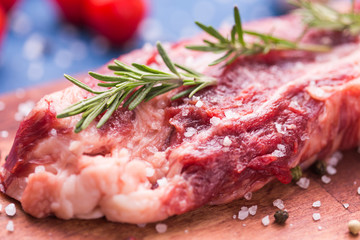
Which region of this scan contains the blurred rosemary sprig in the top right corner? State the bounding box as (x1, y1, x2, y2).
(289, 0, 360, 35)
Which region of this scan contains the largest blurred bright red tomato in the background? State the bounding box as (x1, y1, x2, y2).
(84, 0, 146, 45)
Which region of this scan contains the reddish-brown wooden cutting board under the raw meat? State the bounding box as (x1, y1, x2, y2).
(0, 82, 360, 240)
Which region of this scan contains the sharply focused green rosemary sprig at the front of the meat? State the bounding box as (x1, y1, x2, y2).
(57, 42, 217, 133)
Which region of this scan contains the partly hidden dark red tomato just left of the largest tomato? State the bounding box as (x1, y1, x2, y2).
(54, 0, 86, 25)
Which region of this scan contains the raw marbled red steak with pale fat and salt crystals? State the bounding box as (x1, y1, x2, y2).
(1, 11, 360, 223)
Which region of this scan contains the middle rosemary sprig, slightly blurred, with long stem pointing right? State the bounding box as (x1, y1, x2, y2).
(186, 6, 329, 66)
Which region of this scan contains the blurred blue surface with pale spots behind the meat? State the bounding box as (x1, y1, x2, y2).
(0, 0, 281, 94)
